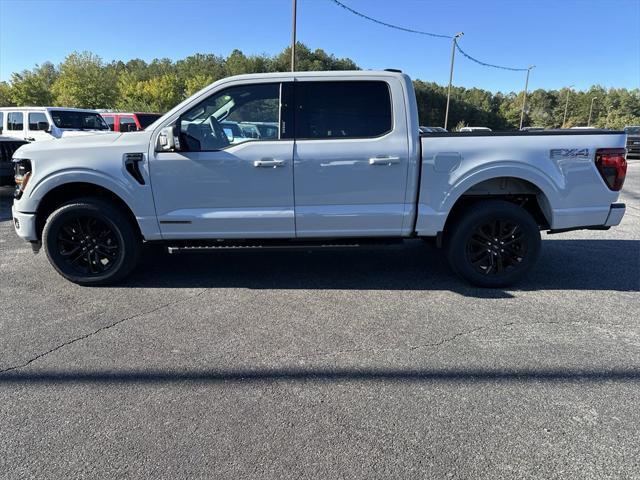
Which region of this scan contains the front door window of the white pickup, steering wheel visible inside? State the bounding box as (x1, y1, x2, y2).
(180, 83, 280, 151)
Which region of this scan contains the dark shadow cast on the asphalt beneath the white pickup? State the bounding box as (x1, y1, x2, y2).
(118, 240, 640, 298)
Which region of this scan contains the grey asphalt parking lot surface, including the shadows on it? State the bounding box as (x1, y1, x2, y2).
(0, 162, 640, 479)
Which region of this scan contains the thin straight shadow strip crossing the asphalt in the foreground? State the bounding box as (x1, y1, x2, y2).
(0, 368, 640, 386)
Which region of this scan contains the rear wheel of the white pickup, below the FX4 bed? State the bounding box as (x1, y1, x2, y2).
(445, 200, 541, 287)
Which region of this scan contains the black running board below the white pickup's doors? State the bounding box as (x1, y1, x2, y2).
(167, 238, 402, 254)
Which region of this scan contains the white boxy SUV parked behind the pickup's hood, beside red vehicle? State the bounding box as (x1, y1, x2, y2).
(0, 107, 109, 142)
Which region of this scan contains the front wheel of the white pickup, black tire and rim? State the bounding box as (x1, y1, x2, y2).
(42, 198, 142, 285)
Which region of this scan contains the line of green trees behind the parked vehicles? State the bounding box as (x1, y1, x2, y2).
(0, 44, 640, 130)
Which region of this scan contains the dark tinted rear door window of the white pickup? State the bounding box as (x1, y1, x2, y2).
(296, 81, 391, 138)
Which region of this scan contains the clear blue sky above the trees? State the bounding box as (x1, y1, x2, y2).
(0, 0, 640, 91)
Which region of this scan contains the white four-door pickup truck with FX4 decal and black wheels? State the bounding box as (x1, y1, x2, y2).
(13, 71, 626, 287)
